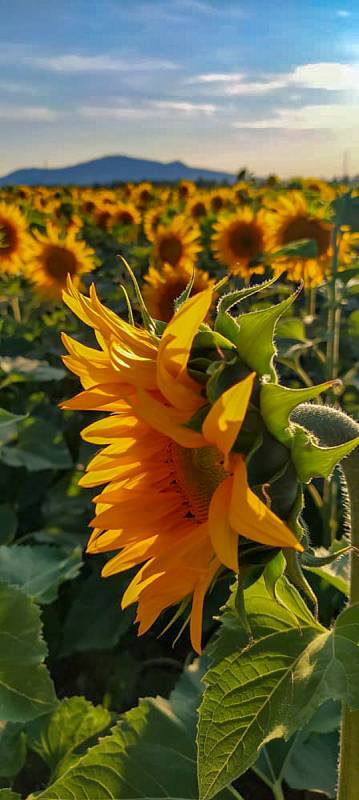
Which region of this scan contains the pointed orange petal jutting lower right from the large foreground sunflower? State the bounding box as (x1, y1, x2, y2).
(229, 457, 303, 551)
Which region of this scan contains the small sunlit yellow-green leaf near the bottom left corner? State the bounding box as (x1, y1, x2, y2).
(26, 697, 112, 778)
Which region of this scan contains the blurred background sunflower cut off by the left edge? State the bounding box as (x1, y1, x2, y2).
(0, 202, 30, 273)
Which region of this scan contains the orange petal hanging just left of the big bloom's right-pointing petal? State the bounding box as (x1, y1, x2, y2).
(208, 478, 238, 572)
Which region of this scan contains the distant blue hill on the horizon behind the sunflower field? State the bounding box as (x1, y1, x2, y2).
(0, 156, 234, 186)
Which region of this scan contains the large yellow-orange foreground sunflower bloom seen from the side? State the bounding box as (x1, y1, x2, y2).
(63, 279, 302, 652)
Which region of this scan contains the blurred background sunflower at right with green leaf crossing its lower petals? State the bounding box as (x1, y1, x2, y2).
(266, 191, 334, 286)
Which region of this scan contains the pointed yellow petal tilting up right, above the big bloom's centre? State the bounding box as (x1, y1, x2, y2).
(202, 372, 256, 460)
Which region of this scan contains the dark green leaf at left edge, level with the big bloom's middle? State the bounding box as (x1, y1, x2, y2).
(0, 417, 72, 471)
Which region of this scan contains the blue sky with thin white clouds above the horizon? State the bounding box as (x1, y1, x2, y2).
(0, 0, 359, 176)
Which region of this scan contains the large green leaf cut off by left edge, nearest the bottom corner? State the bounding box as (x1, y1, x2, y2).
(0, 584, 56, 722)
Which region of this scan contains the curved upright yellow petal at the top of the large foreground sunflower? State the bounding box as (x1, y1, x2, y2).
(157, 289, 212, 411)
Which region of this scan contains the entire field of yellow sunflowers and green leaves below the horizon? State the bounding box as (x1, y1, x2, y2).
(0, 174, 359, 800)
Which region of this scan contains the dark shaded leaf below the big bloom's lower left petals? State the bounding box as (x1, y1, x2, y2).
(61, 572, 134, 656)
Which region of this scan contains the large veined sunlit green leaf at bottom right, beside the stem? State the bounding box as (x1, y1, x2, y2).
(198, 588, 359, 800)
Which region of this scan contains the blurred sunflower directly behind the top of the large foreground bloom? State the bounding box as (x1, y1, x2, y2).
(143, 264, 214, 322)
